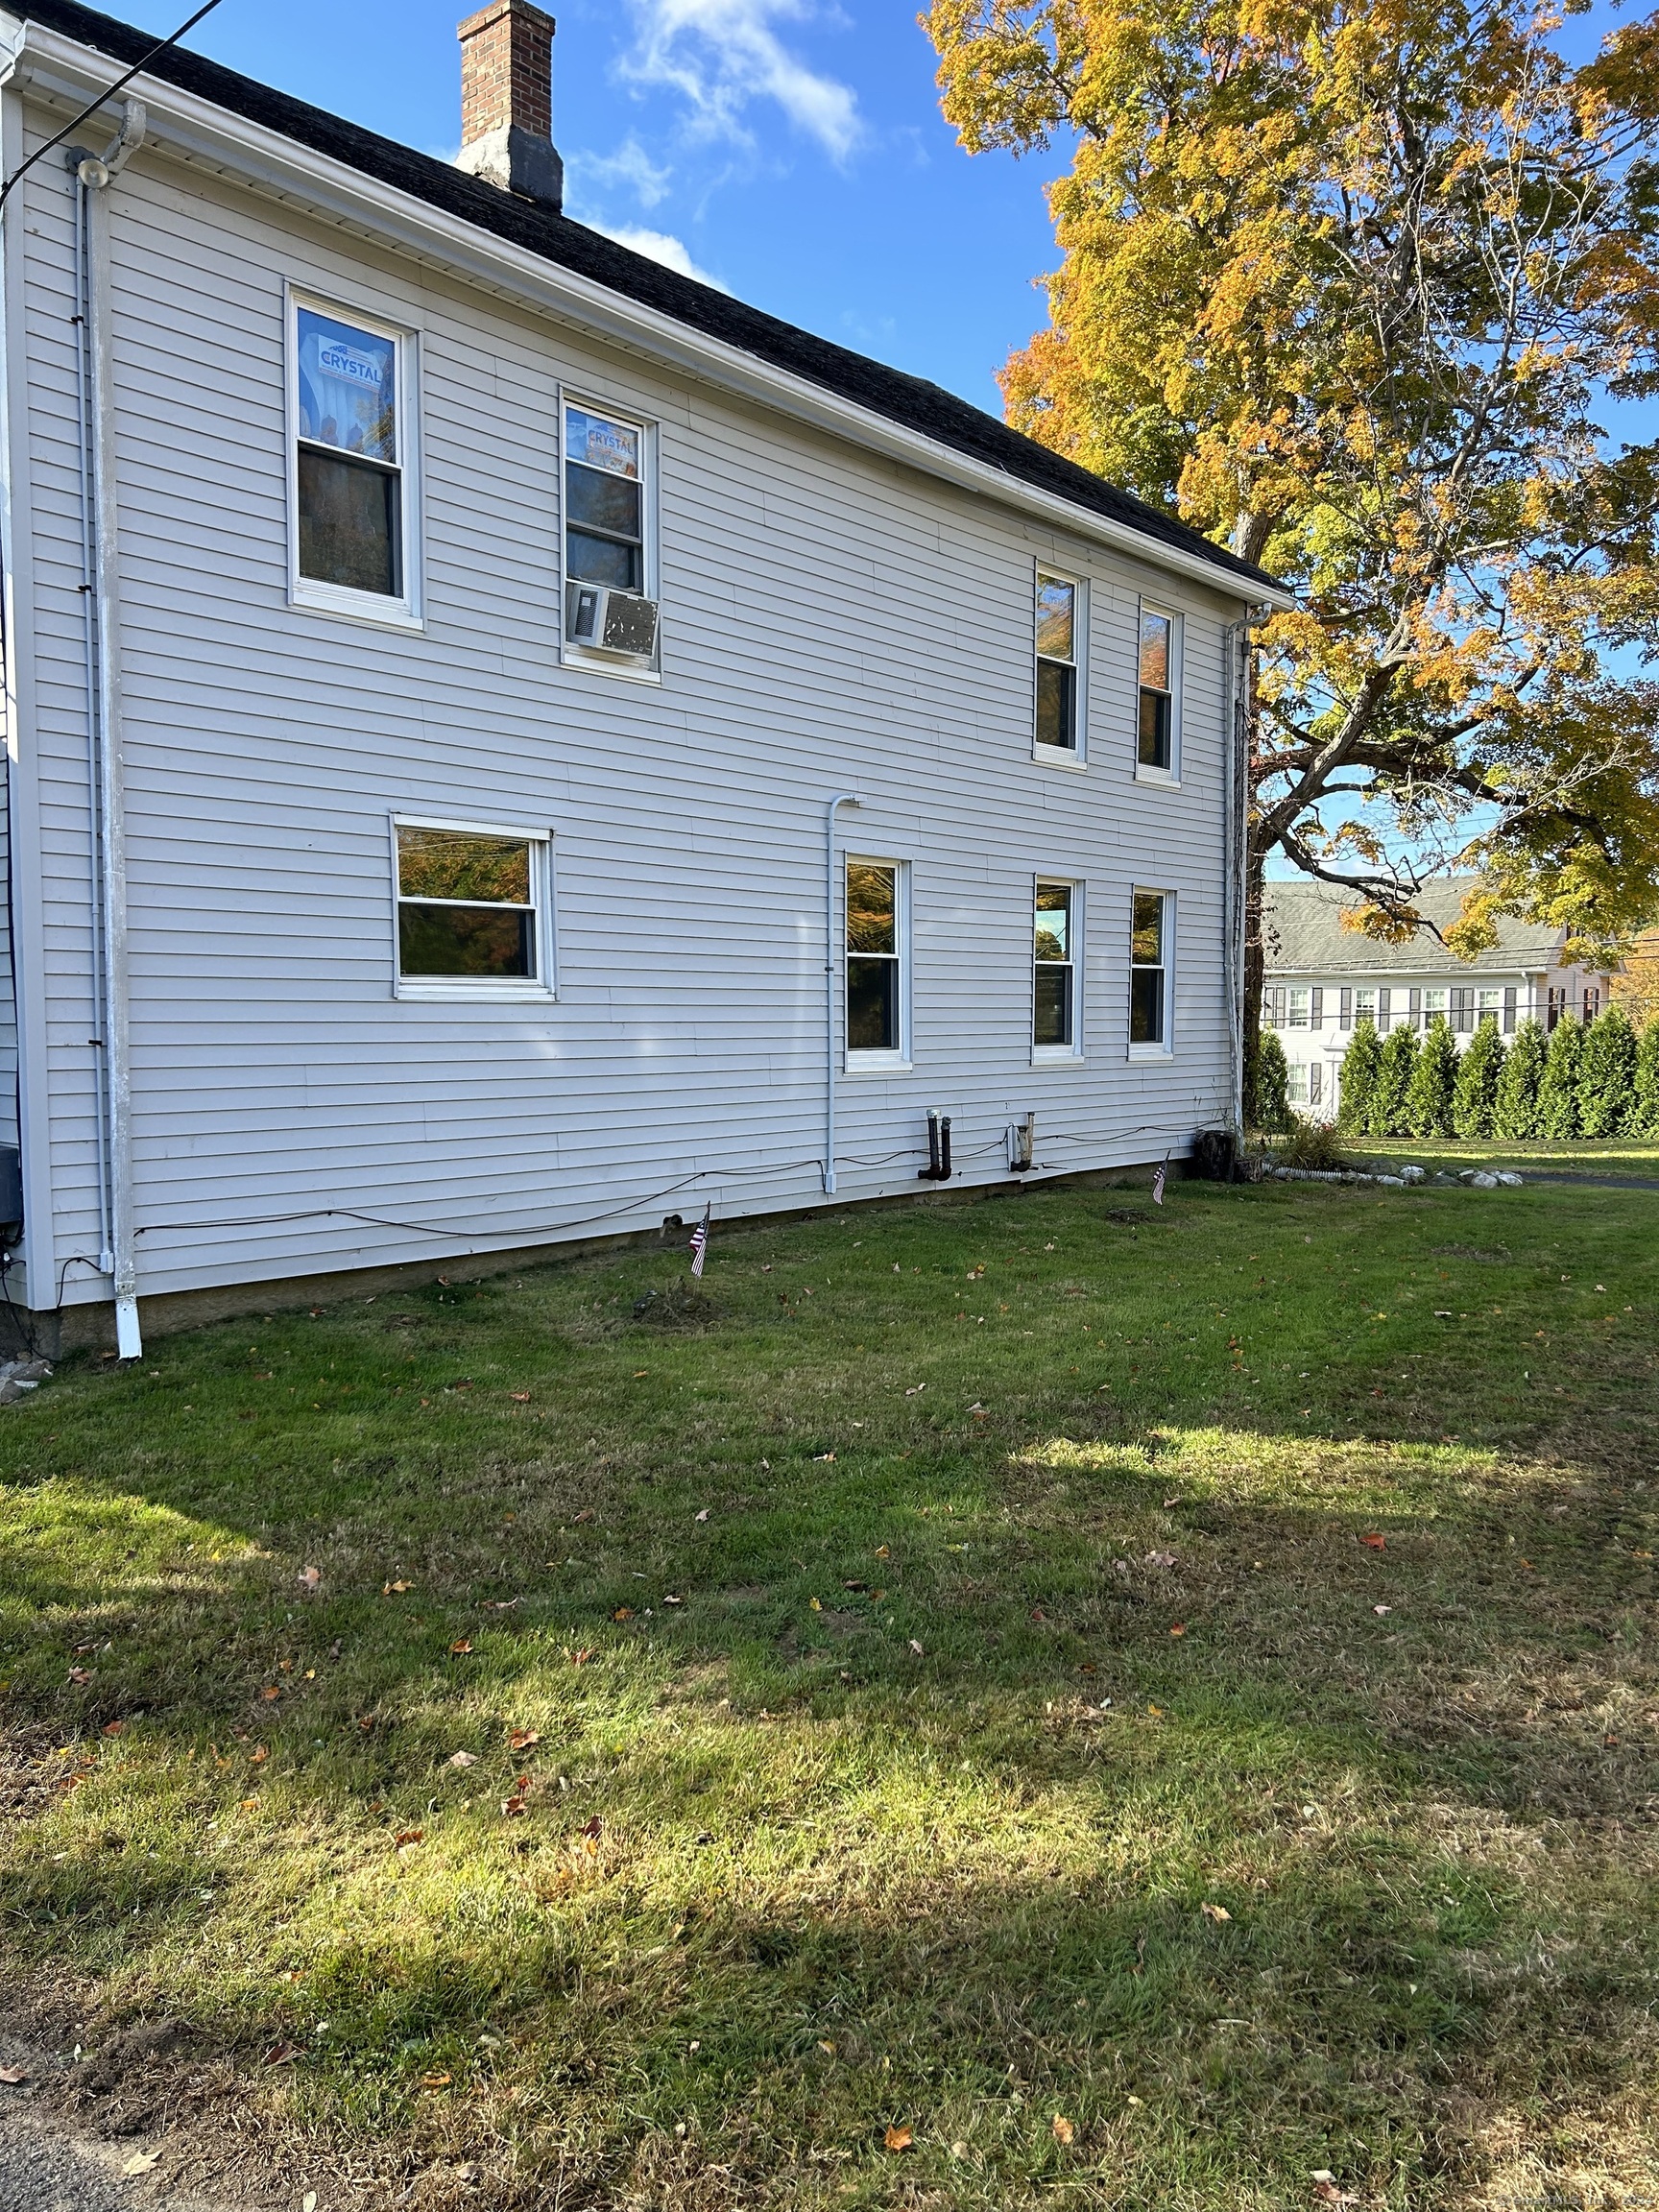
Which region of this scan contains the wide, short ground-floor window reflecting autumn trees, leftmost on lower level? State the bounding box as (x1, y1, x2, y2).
(394, 821, 548, 998)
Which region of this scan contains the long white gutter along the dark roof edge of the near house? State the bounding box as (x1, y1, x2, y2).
(0, 15, 1296, 611)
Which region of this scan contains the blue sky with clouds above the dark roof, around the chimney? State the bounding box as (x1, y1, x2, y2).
(107, 0, 1062, 412)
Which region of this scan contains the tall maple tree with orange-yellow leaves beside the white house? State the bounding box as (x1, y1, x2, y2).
(923, 0, 1659, 1106)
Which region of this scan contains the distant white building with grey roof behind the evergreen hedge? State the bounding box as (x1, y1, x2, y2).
(1261, 876, 1610, 1121)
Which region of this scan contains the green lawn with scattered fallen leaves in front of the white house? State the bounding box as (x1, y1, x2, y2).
(0, 1186, 1659, 2212)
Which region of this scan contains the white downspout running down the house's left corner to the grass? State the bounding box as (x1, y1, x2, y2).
(68, 100, 144, 1360)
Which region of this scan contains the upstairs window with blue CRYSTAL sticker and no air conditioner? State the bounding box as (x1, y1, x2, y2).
(292, 301, 414, 615)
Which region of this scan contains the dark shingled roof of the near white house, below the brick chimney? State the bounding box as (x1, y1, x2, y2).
(22, 0, 1274, 597)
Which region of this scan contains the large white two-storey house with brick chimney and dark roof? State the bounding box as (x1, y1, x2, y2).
(0, 0, 1289, 1352)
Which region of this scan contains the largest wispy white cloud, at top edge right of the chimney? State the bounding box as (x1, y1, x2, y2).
(624, 0, 863, 161)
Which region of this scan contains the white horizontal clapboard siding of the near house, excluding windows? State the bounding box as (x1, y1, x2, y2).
(0, 104, 1238, 1303)
